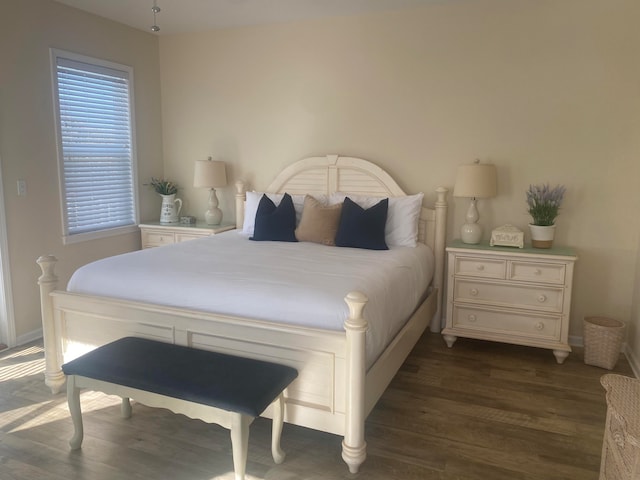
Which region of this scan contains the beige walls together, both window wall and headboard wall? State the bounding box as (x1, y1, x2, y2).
(0, 0, 640, 368)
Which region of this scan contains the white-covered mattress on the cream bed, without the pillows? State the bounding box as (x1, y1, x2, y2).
(67, 231, 434, 364)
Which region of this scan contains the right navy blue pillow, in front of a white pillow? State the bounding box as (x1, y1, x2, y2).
(336, 197, 389, 250)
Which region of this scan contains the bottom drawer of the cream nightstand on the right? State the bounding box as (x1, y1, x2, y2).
(453, 305, 561, 340)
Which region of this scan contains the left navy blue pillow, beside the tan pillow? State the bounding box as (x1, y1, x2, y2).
(249, 193, 298, 242)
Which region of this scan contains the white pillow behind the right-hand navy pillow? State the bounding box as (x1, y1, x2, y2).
(329, 193, 424, 247)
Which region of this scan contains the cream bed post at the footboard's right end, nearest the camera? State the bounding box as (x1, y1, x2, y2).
(342, 292, 369, 473)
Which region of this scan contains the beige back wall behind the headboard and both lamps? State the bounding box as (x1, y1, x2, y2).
(160, 0, 640, 362)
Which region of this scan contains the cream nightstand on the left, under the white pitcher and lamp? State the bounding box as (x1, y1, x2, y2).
(138, 222, 236, 248)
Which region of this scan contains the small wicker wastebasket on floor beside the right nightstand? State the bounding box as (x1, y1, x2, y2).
(584, 317, 624, 370)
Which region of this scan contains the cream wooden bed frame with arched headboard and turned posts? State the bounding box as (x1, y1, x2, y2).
(38, 155, 447, 473)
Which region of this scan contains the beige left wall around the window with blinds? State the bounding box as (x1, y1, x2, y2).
(0, 0, 163, 340)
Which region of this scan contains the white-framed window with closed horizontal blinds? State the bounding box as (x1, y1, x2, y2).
(52, 50, 138, 243)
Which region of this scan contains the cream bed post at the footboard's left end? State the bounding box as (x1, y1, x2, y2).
(37, 255, 66, 393)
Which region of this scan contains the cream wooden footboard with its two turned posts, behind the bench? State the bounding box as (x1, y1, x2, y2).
(37, 255, 376, 473)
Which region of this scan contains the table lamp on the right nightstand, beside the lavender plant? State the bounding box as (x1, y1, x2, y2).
(453, 160, 497, 244)
